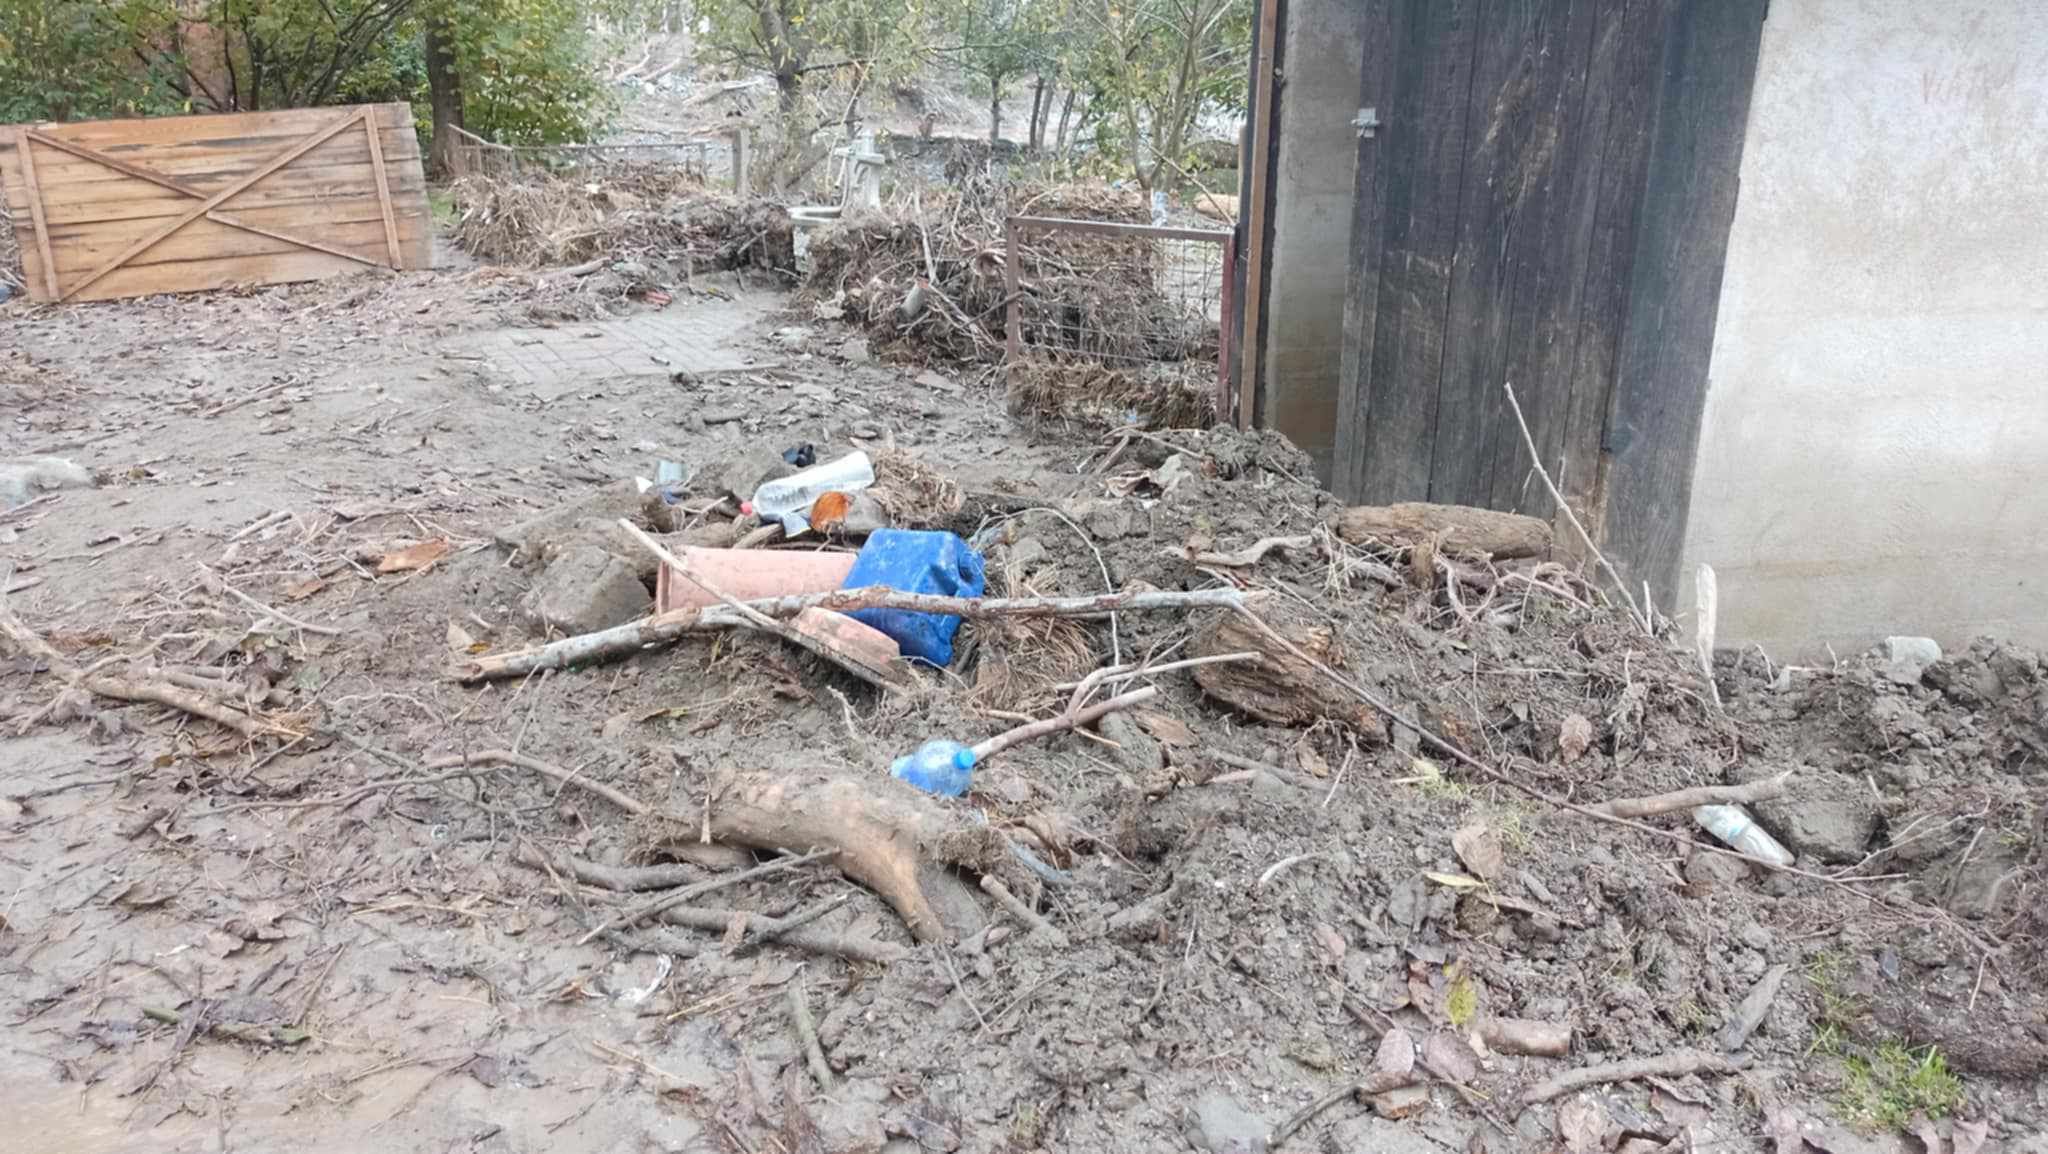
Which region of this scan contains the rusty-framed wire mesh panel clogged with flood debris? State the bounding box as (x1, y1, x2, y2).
(1004, 215, 1235, 422)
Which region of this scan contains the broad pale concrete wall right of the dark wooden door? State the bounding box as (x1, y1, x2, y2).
(1681, 0, 2048, 658)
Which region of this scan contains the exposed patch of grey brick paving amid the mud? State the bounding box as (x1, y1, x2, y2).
(442, 299, 762, 391)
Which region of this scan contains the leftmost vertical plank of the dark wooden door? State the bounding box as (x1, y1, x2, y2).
(1329, 0, 1413, 500)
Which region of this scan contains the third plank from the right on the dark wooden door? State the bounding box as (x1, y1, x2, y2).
(1475, 0, 1604, 517)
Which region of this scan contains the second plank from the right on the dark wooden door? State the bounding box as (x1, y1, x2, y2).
(1548, 0, 1677, 524)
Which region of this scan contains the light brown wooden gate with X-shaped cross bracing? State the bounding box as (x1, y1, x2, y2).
(0, 105, 432, 301)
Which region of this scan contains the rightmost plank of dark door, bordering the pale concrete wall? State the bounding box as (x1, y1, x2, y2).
(1606, 0, 1767, 605)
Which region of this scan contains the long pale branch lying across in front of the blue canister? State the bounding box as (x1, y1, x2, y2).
(451, 586, 1245, 681)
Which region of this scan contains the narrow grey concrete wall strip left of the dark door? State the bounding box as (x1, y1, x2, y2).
(1262, 0, 1364, 482)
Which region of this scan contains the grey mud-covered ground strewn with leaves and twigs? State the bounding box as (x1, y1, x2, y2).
(0, 273, 2048, 1154)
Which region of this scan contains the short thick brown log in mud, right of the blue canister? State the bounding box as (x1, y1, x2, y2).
(1188, 603, 1386, 744)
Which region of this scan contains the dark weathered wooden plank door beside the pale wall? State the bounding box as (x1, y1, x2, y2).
(1335, 0, 1767, 610)
